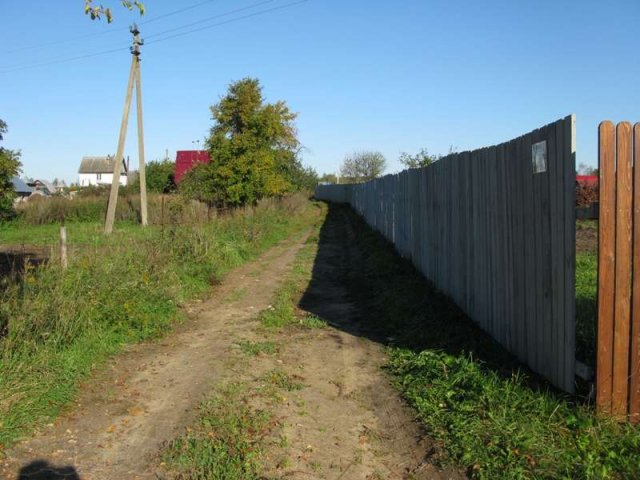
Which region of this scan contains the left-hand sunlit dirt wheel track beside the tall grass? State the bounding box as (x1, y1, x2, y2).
(0, 234, 316, 480)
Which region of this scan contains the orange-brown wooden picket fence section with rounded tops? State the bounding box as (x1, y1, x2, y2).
(596, 121, 640, 423)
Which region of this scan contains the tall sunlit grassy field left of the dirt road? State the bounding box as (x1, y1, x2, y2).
(0, 196, 316, 448)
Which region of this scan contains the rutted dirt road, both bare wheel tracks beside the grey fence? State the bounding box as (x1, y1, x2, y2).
(0, 211, 462, 480)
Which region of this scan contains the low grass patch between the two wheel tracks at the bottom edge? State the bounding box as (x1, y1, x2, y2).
(162, 384, 274, 480)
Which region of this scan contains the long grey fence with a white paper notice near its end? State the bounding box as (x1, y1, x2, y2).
(316, 116, 575, 392)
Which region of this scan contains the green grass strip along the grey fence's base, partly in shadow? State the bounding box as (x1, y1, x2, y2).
(328, 206, 640, 479)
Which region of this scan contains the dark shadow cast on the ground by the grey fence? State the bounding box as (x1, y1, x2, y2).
(300, 204, 562, 395)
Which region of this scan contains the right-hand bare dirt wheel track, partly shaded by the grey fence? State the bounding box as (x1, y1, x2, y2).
(249, 207, 465, 480)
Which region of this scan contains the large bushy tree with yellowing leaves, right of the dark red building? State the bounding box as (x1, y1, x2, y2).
(180, 78, 302, 206)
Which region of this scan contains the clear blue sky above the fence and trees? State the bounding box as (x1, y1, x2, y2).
(0, 0, 640, 181)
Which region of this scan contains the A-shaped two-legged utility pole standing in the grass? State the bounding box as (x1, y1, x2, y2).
(104, 23, 147, 234)
